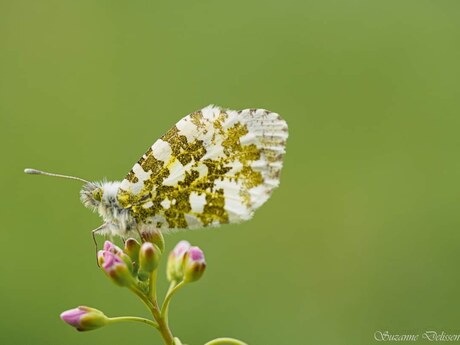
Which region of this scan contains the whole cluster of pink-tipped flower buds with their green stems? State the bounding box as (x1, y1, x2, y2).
(61, 232, 217, 345)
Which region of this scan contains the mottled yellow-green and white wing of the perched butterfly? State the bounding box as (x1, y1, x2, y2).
(117, 106, 288, 229)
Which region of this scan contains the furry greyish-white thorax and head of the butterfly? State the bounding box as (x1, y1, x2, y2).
(80, 181, 136, 235)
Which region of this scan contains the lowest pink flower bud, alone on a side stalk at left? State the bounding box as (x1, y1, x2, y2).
(60, 306, 109, 331)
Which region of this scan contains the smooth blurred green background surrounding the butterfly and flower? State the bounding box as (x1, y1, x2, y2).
(0, 0, 460, 345)
